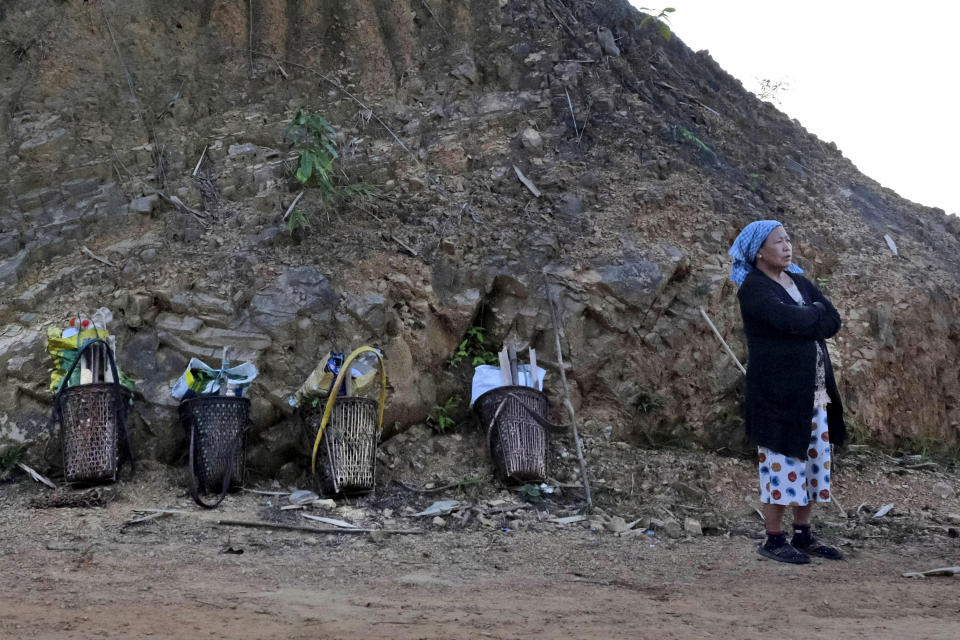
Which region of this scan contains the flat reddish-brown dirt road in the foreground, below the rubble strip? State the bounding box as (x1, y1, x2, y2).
(0, 513, 960, 640)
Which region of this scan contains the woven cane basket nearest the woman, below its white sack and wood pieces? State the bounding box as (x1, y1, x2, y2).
(473, 386, 549, 482)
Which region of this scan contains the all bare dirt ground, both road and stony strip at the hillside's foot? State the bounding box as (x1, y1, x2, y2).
(0, 447, 960, 640)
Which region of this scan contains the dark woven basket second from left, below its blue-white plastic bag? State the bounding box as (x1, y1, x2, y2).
(180, 396, 250, 493)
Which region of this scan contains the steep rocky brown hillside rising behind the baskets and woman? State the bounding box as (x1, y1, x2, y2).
(0, 0, 960, 473)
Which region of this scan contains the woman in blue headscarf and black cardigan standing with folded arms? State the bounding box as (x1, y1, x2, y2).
(729, 220, 846, 564)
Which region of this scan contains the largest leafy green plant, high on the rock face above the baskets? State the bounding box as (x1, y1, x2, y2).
(283, 109, 371, 232)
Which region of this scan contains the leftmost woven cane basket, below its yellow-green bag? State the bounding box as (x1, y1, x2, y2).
(57, 382, 130, 483)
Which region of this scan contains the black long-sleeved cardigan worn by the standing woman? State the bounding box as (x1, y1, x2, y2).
(737, 270, 847, 460)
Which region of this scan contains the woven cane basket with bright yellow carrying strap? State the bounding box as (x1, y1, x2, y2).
(305, 347, 387, 494)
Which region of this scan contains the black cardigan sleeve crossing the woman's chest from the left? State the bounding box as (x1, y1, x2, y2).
(739, 283, 840, 340)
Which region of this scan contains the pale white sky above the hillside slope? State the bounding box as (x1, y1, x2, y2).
(631, 0, 960, 214)
